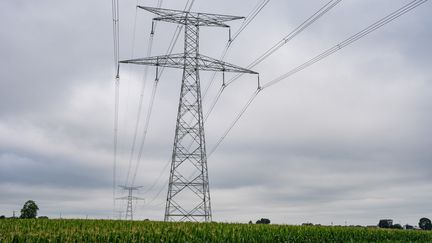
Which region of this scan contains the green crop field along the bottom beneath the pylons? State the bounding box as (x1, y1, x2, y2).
(0, 219, 432, 243)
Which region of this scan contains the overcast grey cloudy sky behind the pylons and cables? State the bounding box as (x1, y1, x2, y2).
(0, 0, 432, 224)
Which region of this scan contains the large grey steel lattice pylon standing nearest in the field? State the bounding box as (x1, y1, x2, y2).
(121, 6, 258, 222)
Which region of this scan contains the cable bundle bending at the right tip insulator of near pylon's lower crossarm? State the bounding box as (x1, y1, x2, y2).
(209, 0, 428, 157)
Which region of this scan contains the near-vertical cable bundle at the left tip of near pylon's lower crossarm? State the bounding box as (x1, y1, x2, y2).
(111, 0, 120, 217)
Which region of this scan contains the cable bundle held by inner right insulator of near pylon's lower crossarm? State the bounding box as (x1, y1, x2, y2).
(205, 0, 342, 123)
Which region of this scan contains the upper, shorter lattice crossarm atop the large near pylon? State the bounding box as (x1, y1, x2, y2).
(138, 6, 244, 27)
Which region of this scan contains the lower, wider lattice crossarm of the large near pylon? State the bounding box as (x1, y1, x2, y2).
(120, 54, 258, 74)
